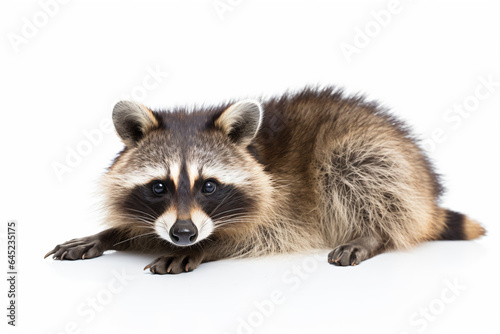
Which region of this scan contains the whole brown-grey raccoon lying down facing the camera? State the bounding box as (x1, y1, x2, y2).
(45, 87, 485, 274)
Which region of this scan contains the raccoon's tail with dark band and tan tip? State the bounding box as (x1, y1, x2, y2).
(436, 209, 486, 240)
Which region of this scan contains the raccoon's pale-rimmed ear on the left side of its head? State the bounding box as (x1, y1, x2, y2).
(113, 101, 158, 146)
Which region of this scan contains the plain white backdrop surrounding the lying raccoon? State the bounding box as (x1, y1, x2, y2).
(0, 0, 500, 334)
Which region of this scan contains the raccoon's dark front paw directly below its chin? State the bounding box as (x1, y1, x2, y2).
(144, 254, 203, 275)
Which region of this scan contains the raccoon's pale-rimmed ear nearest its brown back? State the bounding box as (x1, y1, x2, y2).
(215, 100, 264, 145)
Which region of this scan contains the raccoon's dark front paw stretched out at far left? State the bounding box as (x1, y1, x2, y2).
(44, 237, 106, 261)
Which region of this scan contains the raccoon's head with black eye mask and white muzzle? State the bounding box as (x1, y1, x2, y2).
(102, 100, 273, 246)
